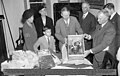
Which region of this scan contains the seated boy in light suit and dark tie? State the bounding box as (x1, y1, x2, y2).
(34, 27, 56, 53)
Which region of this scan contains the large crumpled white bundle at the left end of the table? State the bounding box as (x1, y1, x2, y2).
(1, 50, 38, 69)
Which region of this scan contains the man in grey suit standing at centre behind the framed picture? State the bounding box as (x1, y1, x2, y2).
(55, 6, 83, 49)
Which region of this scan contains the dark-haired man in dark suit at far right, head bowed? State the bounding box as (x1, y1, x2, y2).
(103, 3, 120, 69)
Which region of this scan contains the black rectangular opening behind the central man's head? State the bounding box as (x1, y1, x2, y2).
(53, 3, 82, 23)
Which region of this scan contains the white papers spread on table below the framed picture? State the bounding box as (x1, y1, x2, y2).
(52, 58, 93, 69)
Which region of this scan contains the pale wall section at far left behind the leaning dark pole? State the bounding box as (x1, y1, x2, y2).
(1, 0, 25, 55)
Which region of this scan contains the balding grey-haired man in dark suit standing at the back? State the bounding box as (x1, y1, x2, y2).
(79, 2, 97, 62)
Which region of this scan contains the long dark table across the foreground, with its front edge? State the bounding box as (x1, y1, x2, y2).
(3, 58, 116, 76)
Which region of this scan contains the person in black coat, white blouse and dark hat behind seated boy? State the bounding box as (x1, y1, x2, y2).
(34, 5, 54, 38)
